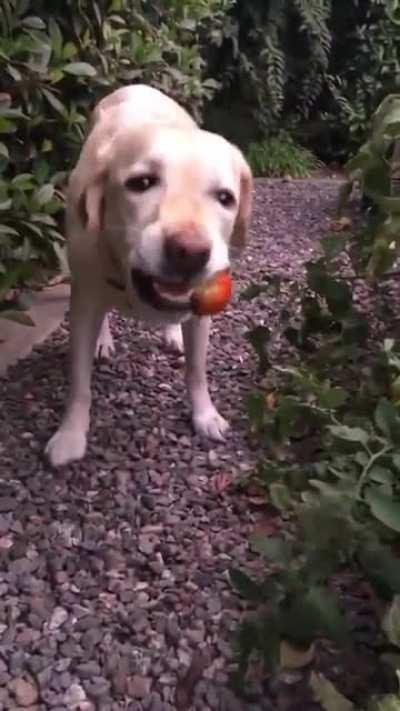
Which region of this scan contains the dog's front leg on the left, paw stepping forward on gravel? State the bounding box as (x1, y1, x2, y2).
(46, 284, 105, 466)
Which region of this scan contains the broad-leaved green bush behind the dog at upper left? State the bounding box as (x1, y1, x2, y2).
(0, 0, 232, 320)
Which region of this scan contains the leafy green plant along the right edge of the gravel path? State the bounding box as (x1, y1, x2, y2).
(231, 96, 400, 709)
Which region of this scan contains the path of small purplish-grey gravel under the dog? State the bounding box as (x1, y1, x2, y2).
(0, 181, 337, 711)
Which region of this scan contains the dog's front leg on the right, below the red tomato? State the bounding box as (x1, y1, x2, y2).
(182, 316, 229, 440)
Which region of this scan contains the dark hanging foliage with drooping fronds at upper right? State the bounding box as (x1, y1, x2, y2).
(209, 0, 400, 161)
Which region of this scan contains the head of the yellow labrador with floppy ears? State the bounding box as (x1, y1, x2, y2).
(71, 124, 252, 308)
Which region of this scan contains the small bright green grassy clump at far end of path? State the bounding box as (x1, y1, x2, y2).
(247, 135, 320, 178)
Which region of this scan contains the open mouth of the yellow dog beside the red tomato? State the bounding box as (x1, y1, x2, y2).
(131, 269, 193, 311)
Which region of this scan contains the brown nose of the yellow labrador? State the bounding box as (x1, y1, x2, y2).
(164, 232, 211, 277)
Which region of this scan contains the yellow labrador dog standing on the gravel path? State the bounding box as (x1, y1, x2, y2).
(46, 85, 252, 466)
